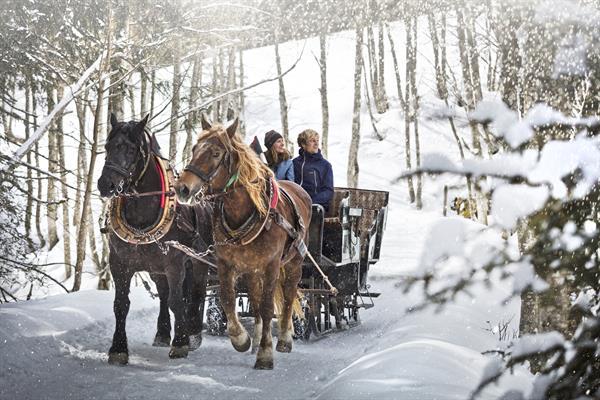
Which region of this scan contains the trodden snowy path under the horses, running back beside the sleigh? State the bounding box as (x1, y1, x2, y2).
(0, 203, 524, 400)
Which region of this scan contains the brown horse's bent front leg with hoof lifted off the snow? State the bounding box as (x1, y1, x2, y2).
(219, 265, 251, 352)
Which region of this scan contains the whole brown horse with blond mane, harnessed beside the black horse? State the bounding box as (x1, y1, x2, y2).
(175, 117, 311, 369)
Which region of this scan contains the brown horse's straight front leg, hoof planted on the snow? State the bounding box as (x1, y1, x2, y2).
(254, 260, 279, 369)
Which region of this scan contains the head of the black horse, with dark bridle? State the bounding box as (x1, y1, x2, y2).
(98, 114, 149, 197)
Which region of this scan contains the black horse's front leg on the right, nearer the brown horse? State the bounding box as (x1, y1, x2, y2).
(166, 265, 190, 358)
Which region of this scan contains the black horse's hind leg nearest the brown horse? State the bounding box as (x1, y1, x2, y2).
(187, 262, 208, 350)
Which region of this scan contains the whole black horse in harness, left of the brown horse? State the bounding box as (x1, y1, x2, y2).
(98, 115, 212, 364)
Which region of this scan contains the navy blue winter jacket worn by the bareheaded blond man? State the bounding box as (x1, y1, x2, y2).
(294, 149, 333, 211)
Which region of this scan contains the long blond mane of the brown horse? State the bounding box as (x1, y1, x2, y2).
(199, 125, 273, 216)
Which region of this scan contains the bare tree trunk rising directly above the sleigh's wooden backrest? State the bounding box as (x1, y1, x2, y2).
(347, 27, 363, 188)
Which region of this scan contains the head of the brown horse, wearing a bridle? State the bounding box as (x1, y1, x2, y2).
(175, 115, 238, 203)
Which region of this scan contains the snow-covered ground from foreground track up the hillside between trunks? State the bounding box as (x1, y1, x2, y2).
(0, 25, 530, 399)
